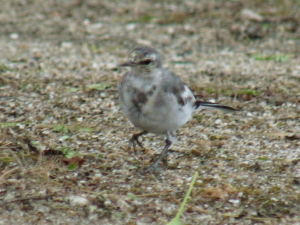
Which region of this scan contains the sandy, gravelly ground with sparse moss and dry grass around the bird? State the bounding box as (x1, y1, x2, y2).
(0, 0, 300, 225)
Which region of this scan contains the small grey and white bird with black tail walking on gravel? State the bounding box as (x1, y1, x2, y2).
(118, 46, 236, 173)
